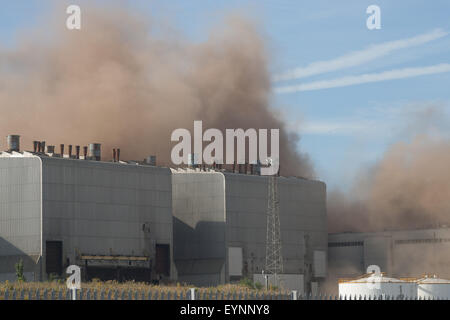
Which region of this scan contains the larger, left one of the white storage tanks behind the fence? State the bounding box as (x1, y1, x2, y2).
(339, 275, 417, 299)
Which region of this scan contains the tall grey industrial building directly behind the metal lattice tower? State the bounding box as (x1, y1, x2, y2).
(172, 169, 327, 292)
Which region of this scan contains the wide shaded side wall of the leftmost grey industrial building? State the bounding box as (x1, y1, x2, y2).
(42, 158, 173, 274)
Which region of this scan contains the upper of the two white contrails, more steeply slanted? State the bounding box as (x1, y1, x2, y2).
(273, 29, 448, 82)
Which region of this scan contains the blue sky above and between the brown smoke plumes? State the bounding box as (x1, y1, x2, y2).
(0, 0, 450, 188)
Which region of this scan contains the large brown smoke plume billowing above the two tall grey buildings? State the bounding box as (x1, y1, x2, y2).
(0, 5, 313, 177)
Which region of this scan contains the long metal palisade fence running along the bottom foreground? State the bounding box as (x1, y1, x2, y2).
(0, 289, 441, 300)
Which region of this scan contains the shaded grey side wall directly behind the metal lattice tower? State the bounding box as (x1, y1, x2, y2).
(225, 173, 327, 284)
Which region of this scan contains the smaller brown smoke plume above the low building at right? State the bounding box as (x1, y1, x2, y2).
(328, 135, 450, 232)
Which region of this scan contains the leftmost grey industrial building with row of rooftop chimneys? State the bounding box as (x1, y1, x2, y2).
(0, 136, 175, 281)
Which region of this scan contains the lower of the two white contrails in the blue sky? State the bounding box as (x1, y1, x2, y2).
(275, 63, 450, 93)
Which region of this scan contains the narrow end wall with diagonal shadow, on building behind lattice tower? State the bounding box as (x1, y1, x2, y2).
(172, 170, 226, 285)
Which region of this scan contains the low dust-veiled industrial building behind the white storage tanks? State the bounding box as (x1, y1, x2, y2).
(327, 227, 450, 293)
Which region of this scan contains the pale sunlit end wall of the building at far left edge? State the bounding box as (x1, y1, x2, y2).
(0, 157, 41, 280)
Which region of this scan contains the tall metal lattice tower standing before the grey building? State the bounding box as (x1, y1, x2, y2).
(265, 176, 283, 274)
